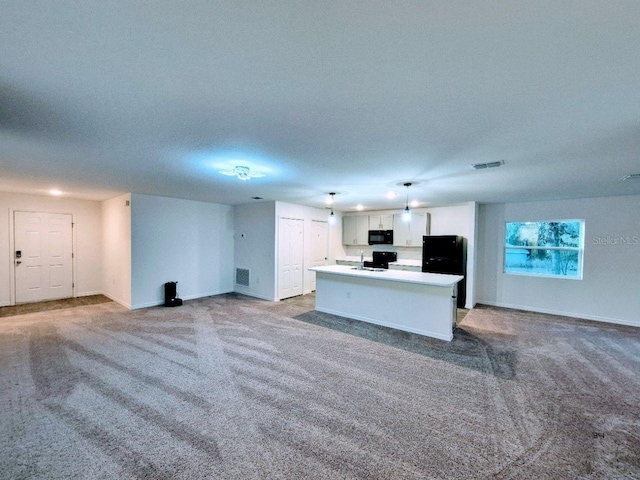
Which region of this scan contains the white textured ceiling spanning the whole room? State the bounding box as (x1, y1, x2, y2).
(0, 0, 640, 210)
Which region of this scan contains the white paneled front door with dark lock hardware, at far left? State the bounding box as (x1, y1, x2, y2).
(14, 212, 73, 303)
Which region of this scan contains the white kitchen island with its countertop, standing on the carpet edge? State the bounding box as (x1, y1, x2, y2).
(309, 265, 464, 341)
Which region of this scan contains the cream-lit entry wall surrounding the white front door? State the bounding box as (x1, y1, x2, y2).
(0, 192, 102, 306)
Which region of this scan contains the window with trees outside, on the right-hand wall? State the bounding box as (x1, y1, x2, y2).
(504, 220, 584, 280)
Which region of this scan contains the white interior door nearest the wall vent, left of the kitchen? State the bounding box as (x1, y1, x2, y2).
(278, 217, 304, 300)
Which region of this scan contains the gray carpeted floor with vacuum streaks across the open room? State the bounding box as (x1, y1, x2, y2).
(0, 294, 640, 479)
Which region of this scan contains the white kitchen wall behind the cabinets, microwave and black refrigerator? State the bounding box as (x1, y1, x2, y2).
(340, 202, 478, 308)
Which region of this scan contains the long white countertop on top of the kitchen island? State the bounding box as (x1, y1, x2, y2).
(309, 265, 464, 287)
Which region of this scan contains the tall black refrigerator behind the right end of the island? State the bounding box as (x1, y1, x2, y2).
(422, 235, 467, 308)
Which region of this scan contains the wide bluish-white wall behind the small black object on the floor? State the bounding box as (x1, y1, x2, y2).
(131, 194, 234, 308)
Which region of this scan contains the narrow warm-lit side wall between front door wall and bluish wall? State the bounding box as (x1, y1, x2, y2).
(101, 193, 131, 308)
